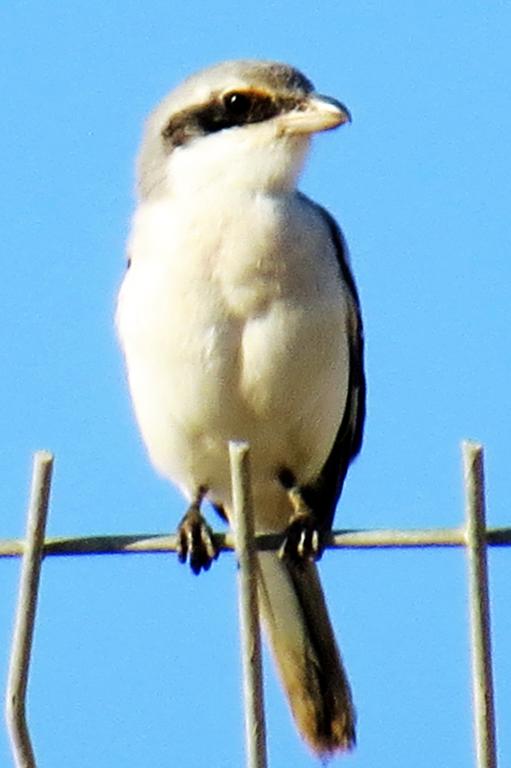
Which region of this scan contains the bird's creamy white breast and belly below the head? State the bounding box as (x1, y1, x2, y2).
(117, 190, 348, 529)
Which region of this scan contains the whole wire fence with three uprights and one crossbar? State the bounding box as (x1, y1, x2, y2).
(0, 442, 511, 768)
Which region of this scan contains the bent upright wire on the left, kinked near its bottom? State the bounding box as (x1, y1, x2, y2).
(5, 451, 53, 768)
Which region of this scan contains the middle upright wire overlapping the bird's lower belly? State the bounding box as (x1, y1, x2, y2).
(229, 442, 267, 768)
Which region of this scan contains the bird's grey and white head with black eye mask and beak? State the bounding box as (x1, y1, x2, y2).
(138, 61, 350, 198)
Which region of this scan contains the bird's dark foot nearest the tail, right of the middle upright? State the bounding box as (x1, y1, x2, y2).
(279, 486, 323, 565)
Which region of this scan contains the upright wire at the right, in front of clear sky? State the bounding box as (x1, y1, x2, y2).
(462, 441, 497, 768)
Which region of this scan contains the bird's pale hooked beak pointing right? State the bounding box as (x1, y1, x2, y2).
(277, 93, 351, 135)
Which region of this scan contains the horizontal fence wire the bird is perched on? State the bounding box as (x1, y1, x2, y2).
(0, 528, 511, 558)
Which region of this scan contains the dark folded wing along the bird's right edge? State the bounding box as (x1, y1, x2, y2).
(302, 198, 366, 531)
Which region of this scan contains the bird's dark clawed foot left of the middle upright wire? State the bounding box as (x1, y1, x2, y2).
(177, 493, 218, 574)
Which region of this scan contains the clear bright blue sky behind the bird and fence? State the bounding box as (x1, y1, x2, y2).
(0, 0, 511, 768)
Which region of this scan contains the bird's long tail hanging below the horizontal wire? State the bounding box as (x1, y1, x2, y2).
(258, 552, 355, 757)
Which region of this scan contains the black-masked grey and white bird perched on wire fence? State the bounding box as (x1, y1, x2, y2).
(116, 60, 366, 759)
